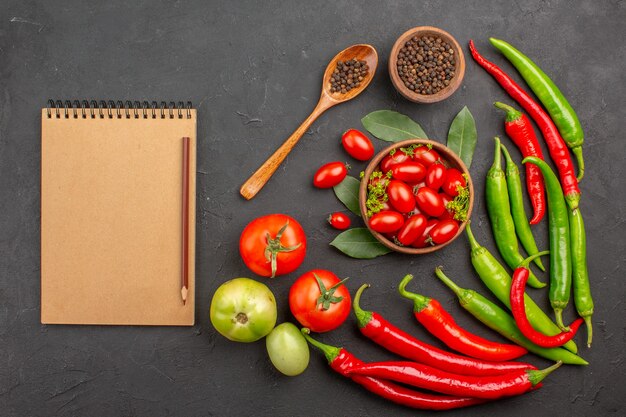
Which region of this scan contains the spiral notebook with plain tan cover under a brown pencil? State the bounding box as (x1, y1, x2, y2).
(41, 101, 196, 325)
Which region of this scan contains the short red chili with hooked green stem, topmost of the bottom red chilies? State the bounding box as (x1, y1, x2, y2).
(394, 274, 528, 361)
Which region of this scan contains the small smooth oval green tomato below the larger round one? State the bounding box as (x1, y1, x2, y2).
(265, 323, 309, 376)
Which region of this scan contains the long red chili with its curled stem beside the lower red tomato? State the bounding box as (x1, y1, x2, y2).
(352, 287, 537, 376)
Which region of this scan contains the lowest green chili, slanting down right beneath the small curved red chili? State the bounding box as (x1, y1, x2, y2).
(435, 267, 588, 365)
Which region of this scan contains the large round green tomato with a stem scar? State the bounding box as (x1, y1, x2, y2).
(211, 278, 276, 342)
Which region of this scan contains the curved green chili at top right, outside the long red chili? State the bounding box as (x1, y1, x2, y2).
(489, 38, 585, 181)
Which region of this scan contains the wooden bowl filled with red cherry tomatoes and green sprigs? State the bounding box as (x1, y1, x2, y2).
(359, 139, 474, 254)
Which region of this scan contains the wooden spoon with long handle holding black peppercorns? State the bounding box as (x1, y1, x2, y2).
(239, 45, 378, 200)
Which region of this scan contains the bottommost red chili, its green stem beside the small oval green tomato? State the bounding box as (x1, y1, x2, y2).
(302, 329, 485, 410)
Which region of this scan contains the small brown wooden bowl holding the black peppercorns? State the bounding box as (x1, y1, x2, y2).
(389, 26, 465, 103)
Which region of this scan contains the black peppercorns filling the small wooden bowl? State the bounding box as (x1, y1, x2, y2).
(397, 36, 456, 95)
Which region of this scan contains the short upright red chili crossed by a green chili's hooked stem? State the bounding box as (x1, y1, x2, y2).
(493, 101, 546, 224)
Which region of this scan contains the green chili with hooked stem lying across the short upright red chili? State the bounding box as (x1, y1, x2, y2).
(522, 156, 572, 330)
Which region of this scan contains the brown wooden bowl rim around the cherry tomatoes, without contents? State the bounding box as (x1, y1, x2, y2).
(359, 139, 474, 255)
